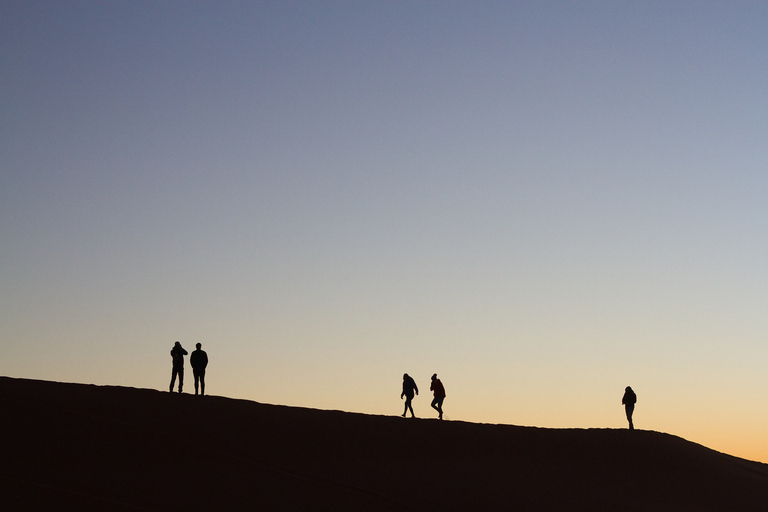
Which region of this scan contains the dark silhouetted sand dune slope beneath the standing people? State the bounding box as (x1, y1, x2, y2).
(0, 377, 768, 512)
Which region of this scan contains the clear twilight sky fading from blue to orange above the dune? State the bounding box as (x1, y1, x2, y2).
(0, 0, 768, 462)
